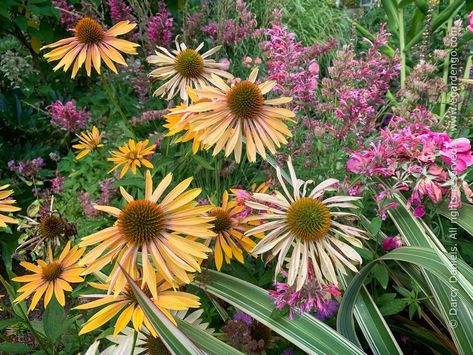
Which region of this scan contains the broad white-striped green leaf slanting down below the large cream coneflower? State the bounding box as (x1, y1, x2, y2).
(195, 270, 364, 355)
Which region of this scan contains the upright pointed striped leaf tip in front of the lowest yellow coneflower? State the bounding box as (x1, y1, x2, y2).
(120, 265, 204, 355)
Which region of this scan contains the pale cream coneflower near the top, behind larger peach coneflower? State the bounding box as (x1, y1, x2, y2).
(147, 41, 233, 102)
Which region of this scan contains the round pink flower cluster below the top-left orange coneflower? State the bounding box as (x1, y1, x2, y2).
(46, 100, 90, 132)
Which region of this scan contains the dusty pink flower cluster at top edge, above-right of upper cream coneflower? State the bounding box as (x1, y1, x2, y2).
(203, 0, 263, 46)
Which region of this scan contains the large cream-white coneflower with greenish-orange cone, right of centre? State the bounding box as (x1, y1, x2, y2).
(246, 160, 366, 290)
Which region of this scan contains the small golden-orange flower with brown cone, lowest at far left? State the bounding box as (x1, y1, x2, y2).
(13, 242, 85, 311)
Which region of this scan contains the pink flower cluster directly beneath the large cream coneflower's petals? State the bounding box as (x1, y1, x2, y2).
(269, 267, 341, 319)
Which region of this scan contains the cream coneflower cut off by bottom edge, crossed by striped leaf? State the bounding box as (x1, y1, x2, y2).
(100, 309, 215, 355)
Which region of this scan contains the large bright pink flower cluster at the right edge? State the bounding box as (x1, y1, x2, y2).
(347, 111, 473, 217)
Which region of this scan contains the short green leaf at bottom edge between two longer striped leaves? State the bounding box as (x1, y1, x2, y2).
(176, 318, 243, 355)
